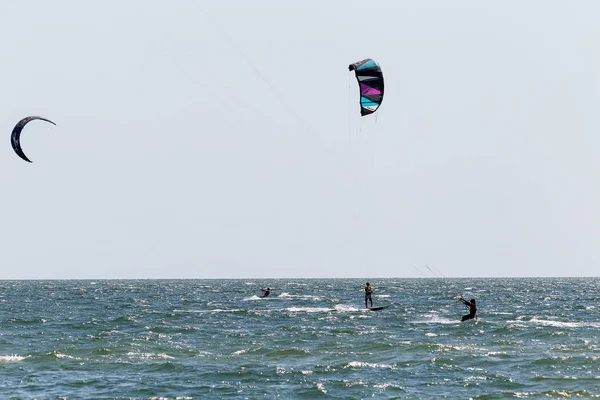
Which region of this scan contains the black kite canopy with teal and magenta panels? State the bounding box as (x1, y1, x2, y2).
(348, 58, 383, 116)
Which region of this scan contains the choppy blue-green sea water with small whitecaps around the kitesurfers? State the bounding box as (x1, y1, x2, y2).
(0, 278, 600, 399)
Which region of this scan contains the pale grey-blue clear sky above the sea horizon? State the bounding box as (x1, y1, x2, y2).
(0, 0, 600, 279)
